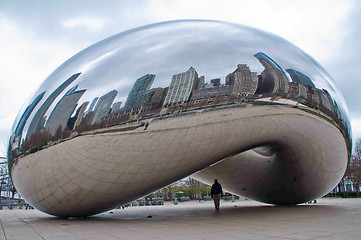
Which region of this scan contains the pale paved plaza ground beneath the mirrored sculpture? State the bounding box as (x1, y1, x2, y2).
(0, 198, 361, 240)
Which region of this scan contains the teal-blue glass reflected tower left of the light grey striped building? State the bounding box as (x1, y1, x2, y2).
(124, 74, 155, 109)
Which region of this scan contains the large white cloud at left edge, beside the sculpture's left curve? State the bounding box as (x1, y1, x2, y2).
(0, 17, 79, 153)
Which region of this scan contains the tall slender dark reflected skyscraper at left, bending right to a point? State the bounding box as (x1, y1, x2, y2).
(26, 73, 81, 137)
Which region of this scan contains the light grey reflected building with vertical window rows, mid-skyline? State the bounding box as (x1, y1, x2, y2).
(163, 67, 198, 107)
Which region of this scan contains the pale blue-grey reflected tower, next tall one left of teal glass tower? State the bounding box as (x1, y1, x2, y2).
(90, 90, 118, 124)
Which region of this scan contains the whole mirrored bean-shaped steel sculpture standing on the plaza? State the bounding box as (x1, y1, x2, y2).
(8, 21, 351, 217)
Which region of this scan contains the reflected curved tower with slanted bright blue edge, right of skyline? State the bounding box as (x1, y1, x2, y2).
(254, 52, 289, 94)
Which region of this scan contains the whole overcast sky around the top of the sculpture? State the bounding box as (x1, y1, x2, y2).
(0, 0, 361, 156)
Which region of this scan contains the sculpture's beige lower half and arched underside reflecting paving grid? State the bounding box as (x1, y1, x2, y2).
(12, 105, 347, 216)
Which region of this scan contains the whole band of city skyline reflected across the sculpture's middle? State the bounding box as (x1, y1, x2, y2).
(9, 52, 349, 163)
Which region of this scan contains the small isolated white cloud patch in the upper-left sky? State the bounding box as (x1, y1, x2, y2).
(62, 16, 105, 32)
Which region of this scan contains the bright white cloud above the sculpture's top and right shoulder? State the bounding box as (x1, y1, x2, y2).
(147, 0, 353, 62)
